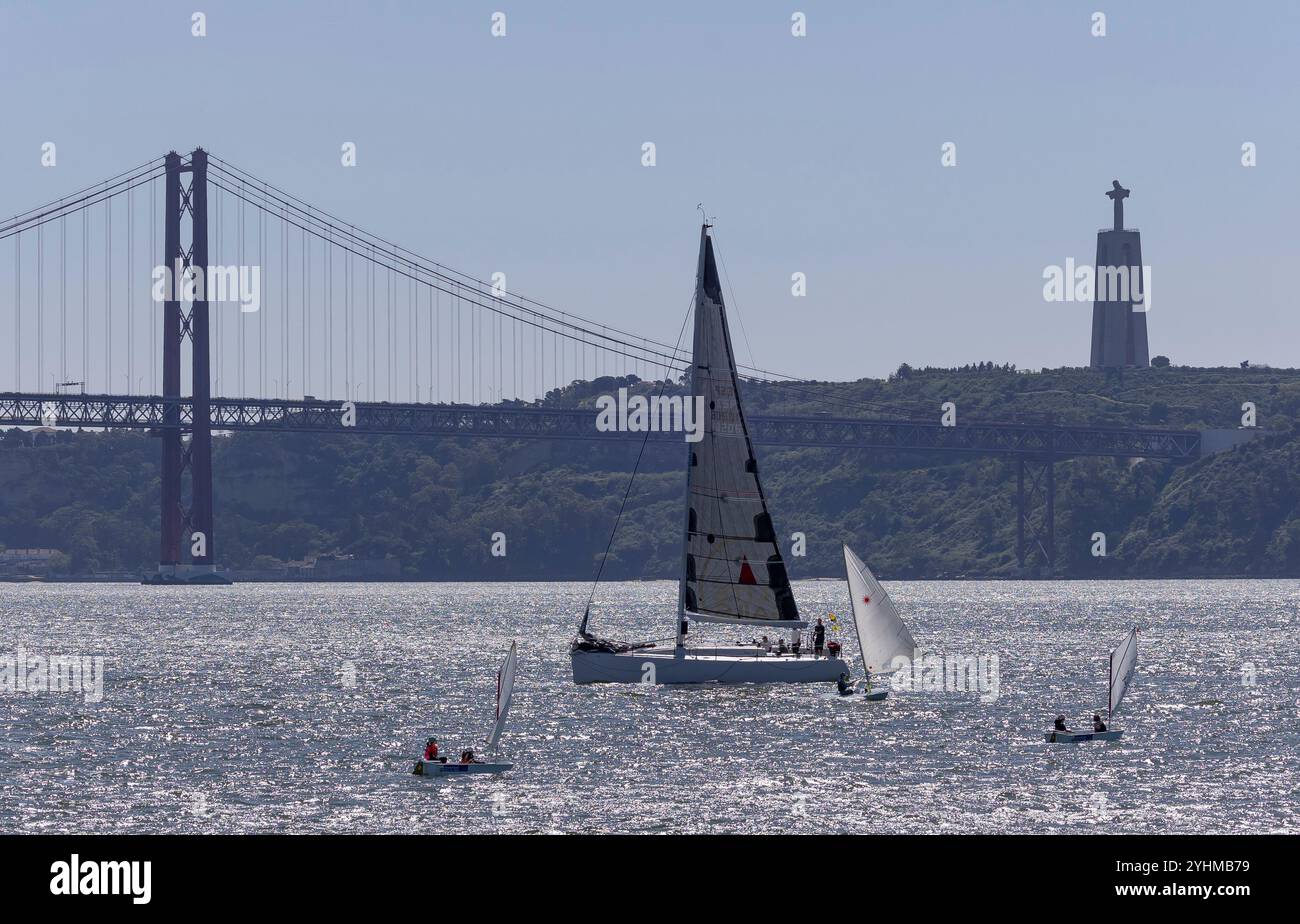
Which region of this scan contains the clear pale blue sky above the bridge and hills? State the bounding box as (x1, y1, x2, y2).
(0, 0, 1300, 379)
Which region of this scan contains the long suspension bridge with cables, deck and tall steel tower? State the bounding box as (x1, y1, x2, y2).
(0, 148, 1232, 582)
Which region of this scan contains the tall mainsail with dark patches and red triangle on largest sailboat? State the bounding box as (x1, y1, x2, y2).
(680, 225, 802, 625)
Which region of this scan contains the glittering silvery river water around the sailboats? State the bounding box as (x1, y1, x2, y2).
(0, 581, 1300, 833)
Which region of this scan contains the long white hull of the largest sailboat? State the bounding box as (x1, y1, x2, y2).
(569, 648, 849, 684)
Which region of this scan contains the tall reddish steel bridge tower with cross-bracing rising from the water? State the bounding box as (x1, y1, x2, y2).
(148, 148, 229, 584)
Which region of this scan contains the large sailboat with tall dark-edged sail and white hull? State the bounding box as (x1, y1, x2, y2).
(571, 224, 848, 684)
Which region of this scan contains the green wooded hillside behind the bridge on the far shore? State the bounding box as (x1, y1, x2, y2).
(0, 363, 1300, 580)
